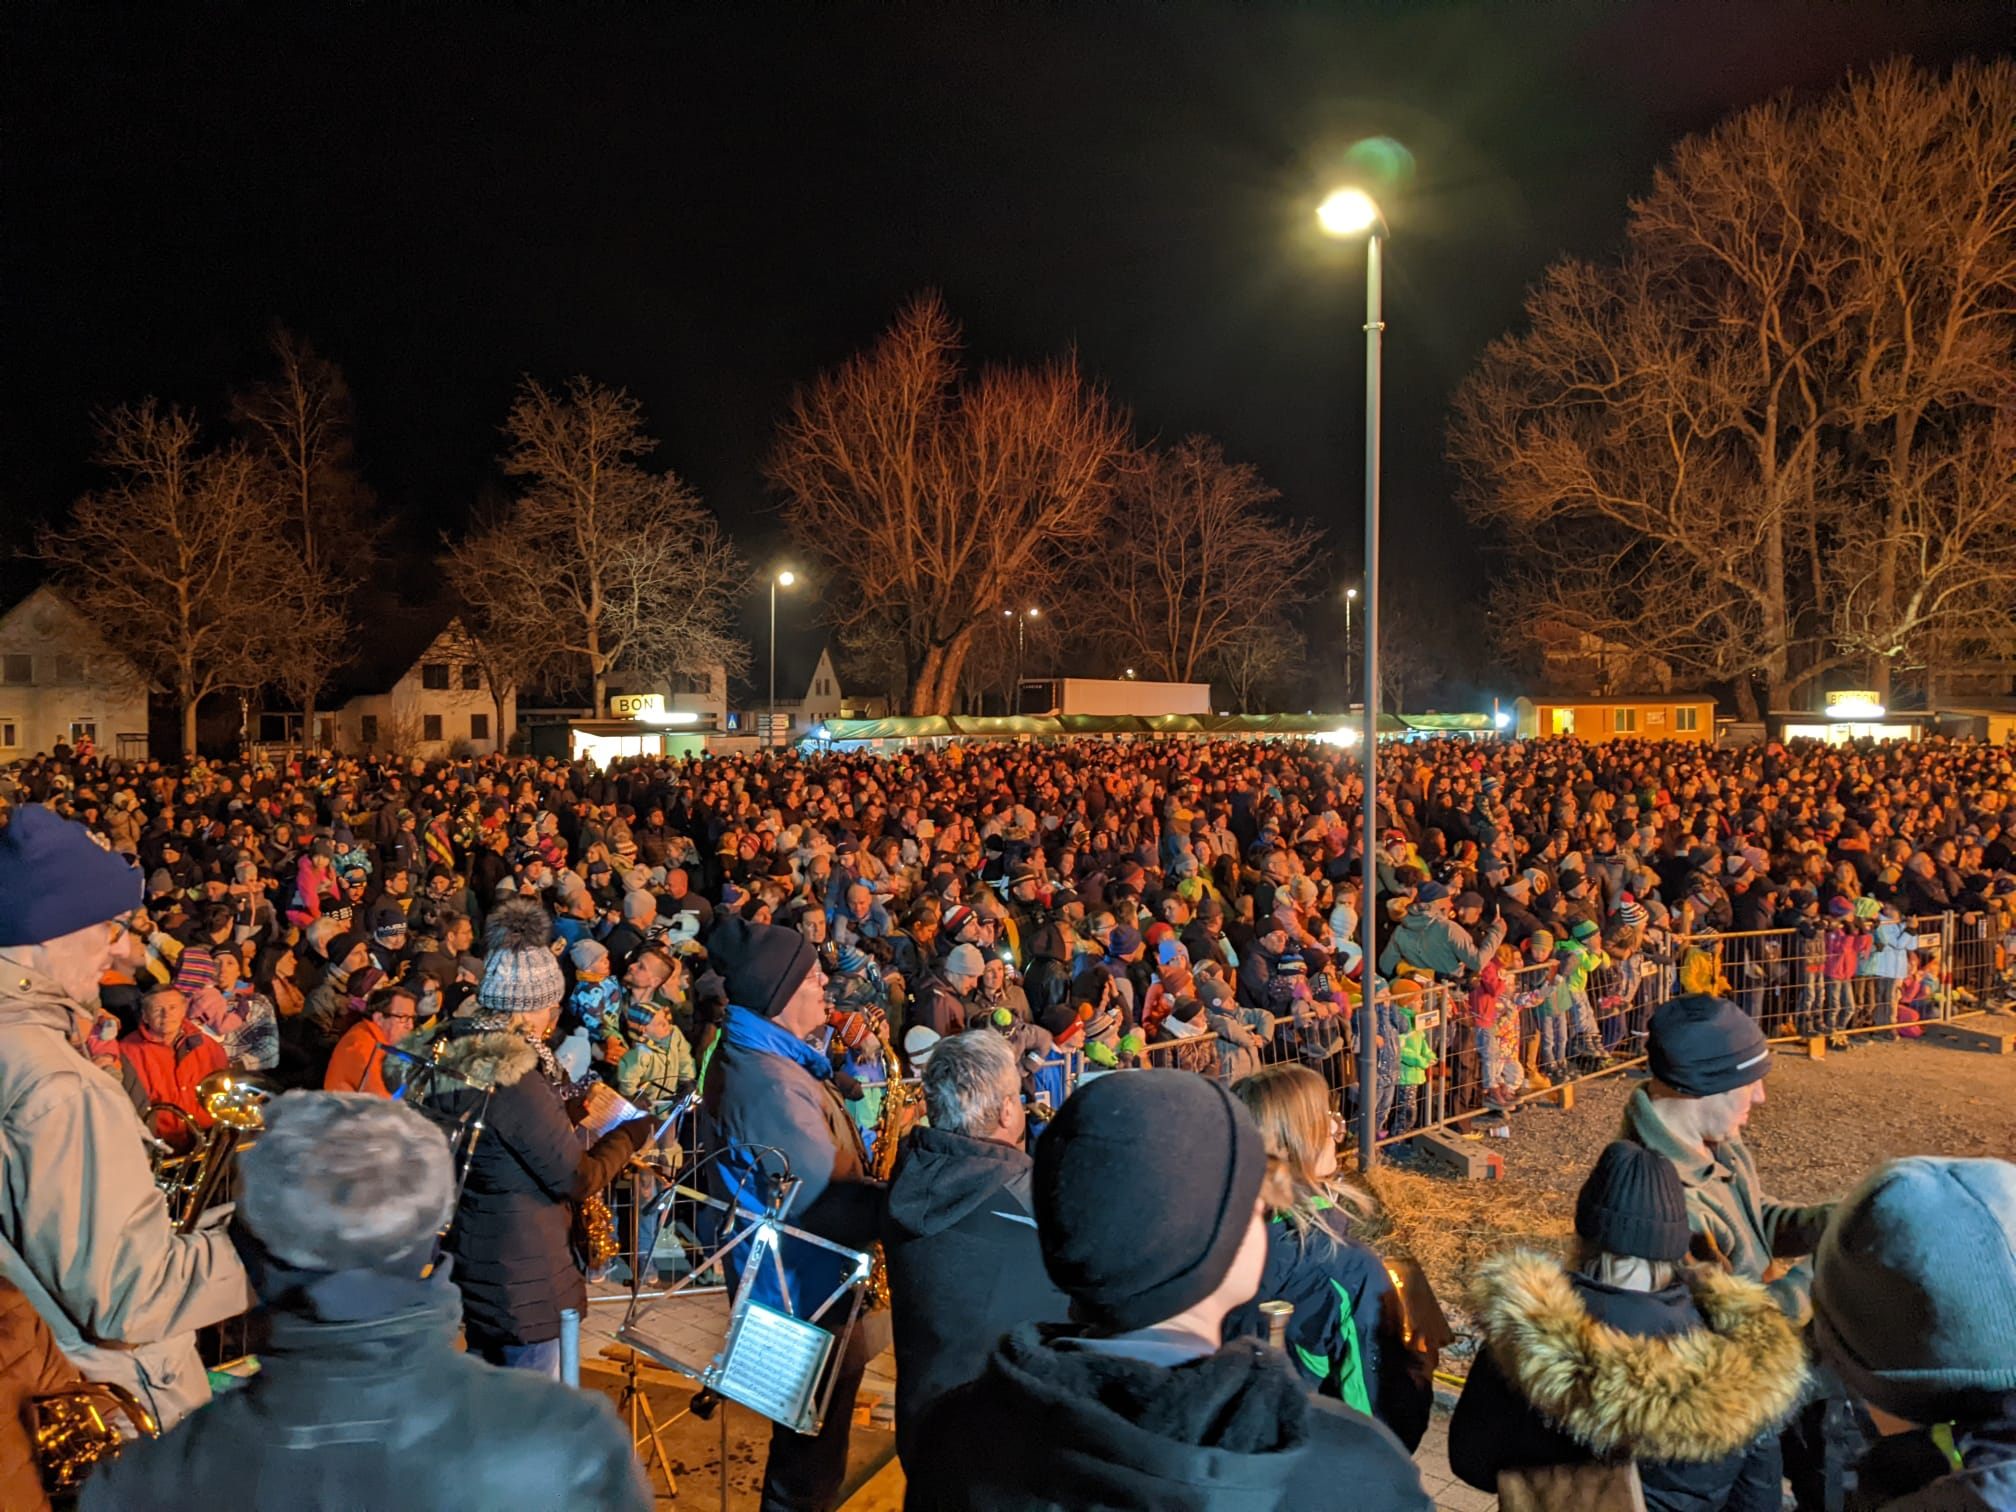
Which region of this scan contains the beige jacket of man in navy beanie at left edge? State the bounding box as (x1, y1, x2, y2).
(0, 968, 252, 1423)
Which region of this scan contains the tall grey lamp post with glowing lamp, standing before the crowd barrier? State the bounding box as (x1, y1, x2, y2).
(1316, 190, 1387, 1171)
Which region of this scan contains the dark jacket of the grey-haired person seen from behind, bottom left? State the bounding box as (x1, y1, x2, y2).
(83, 1272, 651, 1512)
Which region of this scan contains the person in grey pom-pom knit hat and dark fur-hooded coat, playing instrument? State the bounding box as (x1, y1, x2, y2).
(405, 899, 653, 1379)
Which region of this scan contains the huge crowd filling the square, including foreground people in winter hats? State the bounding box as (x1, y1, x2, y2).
(0, 738, 2016, 1508)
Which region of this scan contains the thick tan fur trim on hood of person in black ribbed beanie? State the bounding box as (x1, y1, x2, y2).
(1472, 1252, 1806, 1464)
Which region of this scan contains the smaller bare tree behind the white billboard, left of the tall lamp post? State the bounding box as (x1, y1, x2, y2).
(1083, 435, 1320, 681)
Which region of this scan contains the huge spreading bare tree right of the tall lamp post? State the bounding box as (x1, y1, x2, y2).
(1450, 65, 2016, 716)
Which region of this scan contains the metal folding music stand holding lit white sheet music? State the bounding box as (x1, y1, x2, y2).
(617, 1175, 871, 1435)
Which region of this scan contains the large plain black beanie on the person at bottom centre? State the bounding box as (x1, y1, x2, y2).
(1034, 1070, 1266, 1333)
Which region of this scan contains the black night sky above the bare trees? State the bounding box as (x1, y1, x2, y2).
(0, 0, 2012, 641)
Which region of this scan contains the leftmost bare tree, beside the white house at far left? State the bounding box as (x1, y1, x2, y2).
(40, 399, 302, 756)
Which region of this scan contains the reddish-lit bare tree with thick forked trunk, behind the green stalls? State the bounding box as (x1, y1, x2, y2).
(766, 294, 1125, 714)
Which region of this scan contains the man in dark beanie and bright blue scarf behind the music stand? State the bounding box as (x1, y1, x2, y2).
(702, 917, 883, 1512)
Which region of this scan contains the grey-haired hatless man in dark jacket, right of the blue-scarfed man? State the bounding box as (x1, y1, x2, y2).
(883, 1028, 1068, 1456)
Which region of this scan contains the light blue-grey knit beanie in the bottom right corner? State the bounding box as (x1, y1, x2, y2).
(1812, 1155, 2016, 1423)
